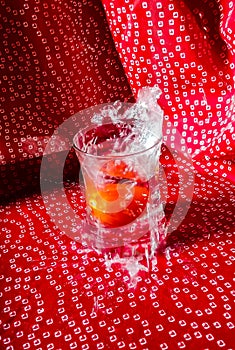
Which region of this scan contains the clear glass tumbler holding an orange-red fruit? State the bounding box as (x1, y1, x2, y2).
(73, 113, 164, 248)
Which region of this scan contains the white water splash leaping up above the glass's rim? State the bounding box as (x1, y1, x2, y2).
(90, 85, 163, 154)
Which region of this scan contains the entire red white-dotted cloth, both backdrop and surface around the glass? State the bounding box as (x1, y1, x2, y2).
(0, 0, 235, 350)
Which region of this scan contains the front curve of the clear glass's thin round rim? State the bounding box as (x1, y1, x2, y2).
(73, 125, 162, 159)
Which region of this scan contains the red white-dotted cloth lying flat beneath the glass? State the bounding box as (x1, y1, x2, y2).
(0, 176, 235, 350)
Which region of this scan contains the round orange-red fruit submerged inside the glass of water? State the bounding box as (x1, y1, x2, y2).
(89, 160, 149, 228)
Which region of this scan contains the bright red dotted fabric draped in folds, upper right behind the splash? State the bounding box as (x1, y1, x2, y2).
(103, 0, 235, 172)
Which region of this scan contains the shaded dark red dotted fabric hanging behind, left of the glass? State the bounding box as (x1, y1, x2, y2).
(0, 1, 132, 198)
